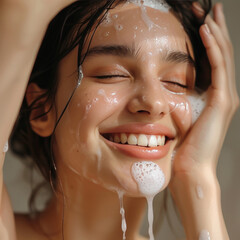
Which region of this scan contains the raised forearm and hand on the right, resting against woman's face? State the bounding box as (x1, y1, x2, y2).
(170, 4, 239, 240)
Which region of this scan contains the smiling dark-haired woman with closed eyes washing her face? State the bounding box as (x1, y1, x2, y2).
(0, 0, 238, 240)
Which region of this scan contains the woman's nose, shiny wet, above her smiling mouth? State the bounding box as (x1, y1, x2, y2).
(128, 80, 169, 118)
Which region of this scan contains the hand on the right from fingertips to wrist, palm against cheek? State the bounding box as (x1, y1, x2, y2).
(173, 4, 239, 180)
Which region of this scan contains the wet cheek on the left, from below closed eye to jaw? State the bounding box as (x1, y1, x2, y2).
(52, 86, 124, 179)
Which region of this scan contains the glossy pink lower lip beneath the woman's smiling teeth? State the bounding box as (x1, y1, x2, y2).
(105, 139, 171, 160)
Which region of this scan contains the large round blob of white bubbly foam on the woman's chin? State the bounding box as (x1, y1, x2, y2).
(132, 161, 165, 196)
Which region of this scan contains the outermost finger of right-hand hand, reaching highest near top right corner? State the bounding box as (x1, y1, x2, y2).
(213, 3, 230, 41)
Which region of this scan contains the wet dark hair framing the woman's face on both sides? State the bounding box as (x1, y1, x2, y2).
(10, 0, 211, 195)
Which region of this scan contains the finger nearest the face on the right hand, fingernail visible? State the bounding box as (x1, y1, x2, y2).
(200, 24, 228, 90)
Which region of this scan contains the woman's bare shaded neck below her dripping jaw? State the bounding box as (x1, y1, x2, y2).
(36, 176, 146, 240)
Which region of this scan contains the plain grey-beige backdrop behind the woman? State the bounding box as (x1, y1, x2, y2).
(4, 0, 240, 240)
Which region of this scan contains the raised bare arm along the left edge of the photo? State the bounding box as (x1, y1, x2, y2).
(0, 0, 74, 240)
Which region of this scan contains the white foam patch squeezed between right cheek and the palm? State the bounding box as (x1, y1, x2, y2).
(187, 92, 207, 124)
